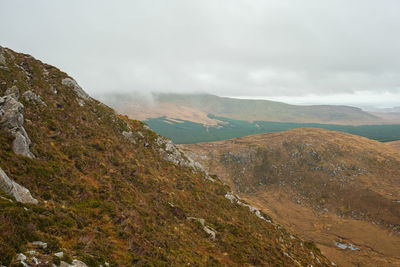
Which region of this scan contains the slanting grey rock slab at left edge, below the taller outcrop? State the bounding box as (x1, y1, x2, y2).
(0, 168, 38, 204)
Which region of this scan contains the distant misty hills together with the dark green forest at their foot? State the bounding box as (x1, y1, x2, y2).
(102, 94, 400, 144)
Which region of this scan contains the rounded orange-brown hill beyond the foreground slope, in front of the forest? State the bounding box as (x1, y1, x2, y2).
(181, 128, 400, 266)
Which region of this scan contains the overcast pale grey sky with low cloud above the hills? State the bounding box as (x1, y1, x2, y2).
(0, 0, 400, 106)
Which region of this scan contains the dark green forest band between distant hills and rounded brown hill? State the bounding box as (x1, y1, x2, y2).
(145, 114, 400, 144)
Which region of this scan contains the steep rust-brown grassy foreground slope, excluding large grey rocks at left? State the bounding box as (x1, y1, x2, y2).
(0, 49, 329, 266)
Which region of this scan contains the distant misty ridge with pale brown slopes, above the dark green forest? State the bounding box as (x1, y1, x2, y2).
(104, 94, 393, 125)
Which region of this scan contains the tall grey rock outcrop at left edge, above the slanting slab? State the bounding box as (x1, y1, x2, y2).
(0, 86, 35, 158)
